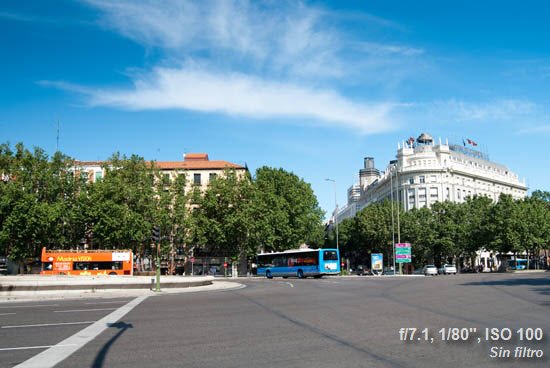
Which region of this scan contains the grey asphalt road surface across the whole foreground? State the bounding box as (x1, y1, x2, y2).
(0, 273, 550, 367)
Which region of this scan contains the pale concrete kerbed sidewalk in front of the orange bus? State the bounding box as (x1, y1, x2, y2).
(0, 275, 242, 303)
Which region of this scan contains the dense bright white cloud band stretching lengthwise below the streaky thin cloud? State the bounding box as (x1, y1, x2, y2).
(76, 67, 394, 133)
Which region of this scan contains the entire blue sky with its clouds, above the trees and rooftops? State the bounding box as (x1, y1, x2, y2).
(0, 0, 550, 217)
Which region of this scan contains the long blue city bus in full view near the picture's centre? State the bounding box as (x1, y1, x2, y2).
(256, 248, 340, 279)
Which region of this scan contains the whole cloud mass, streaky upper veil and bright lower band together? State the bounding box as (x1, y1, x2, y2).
(31, 0, 432, 134)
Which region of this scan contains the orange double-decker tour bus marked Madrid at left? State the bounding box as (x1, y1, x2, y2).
(40, 248, 134, 276)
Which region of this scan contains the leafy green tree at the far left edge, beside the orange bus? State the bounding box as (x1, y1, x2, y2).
(0, 143, 88, 260)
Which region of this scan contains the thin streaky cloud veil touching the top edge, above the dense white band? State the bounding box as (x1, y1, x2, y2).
(85, 0, 341, 76)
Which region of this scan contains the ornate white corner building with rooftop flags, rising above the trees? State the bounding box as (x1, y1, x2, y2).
(338, 133, 527, 222)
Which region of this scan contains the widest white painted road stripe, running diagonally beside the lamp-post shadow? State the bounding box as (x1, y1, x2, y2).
(15, 295, 148, 368)
